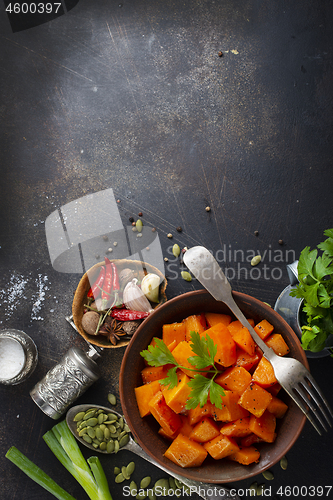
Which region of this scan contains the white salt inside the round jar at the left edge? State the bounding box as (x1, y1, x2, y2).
(0, 337, 25, 380)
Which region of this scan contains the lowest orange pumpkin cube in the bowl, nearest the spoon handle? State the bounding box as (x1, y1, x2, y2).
(164, 434, 207, 468)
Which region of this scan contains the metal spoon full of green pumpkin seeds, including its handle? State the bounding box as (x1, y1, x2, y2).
(66, 404, 240, 500)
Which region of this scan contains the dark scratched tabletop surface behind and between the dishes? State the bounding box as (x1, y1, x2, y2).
(0, 0, 333, 500)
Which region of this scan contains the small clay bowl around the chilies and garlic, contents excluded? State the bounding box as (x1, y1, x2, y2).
(72, 259, 167, 349)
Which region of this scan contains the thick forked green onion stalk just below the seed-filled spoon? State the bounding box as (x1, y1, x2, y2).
(43, 420, 112, 500)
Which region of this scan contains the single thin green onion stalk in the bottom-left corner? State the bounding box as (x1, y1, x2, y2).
(5, 446, 75, 500)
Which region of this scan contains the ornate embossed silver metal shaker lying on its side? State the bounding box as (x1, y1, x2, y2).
(30, 344, 103, 420)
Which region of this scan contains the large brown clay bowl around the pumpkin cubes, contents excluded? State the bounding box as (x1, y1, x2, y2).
(119, 290, 308, 483)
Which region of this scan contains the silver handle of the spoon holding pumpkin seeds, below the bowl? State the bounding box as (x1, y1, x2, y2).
(123, 438, 240, 500)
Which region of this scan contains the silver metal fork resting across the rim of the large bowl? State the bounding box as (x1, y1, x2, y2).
(183, 246, 333, 435)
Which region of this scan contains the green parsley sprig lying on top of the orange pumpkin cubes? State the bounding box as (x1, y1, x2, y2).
(140, 332, 225, 409)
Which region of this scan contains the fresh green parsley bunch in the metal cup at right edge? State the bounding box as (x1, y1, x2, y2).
(290, 229, 333, 352)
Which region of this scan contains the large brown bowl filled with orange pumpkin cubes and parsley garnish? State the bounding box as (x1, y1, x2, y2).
(119, 290, 308, 483)
